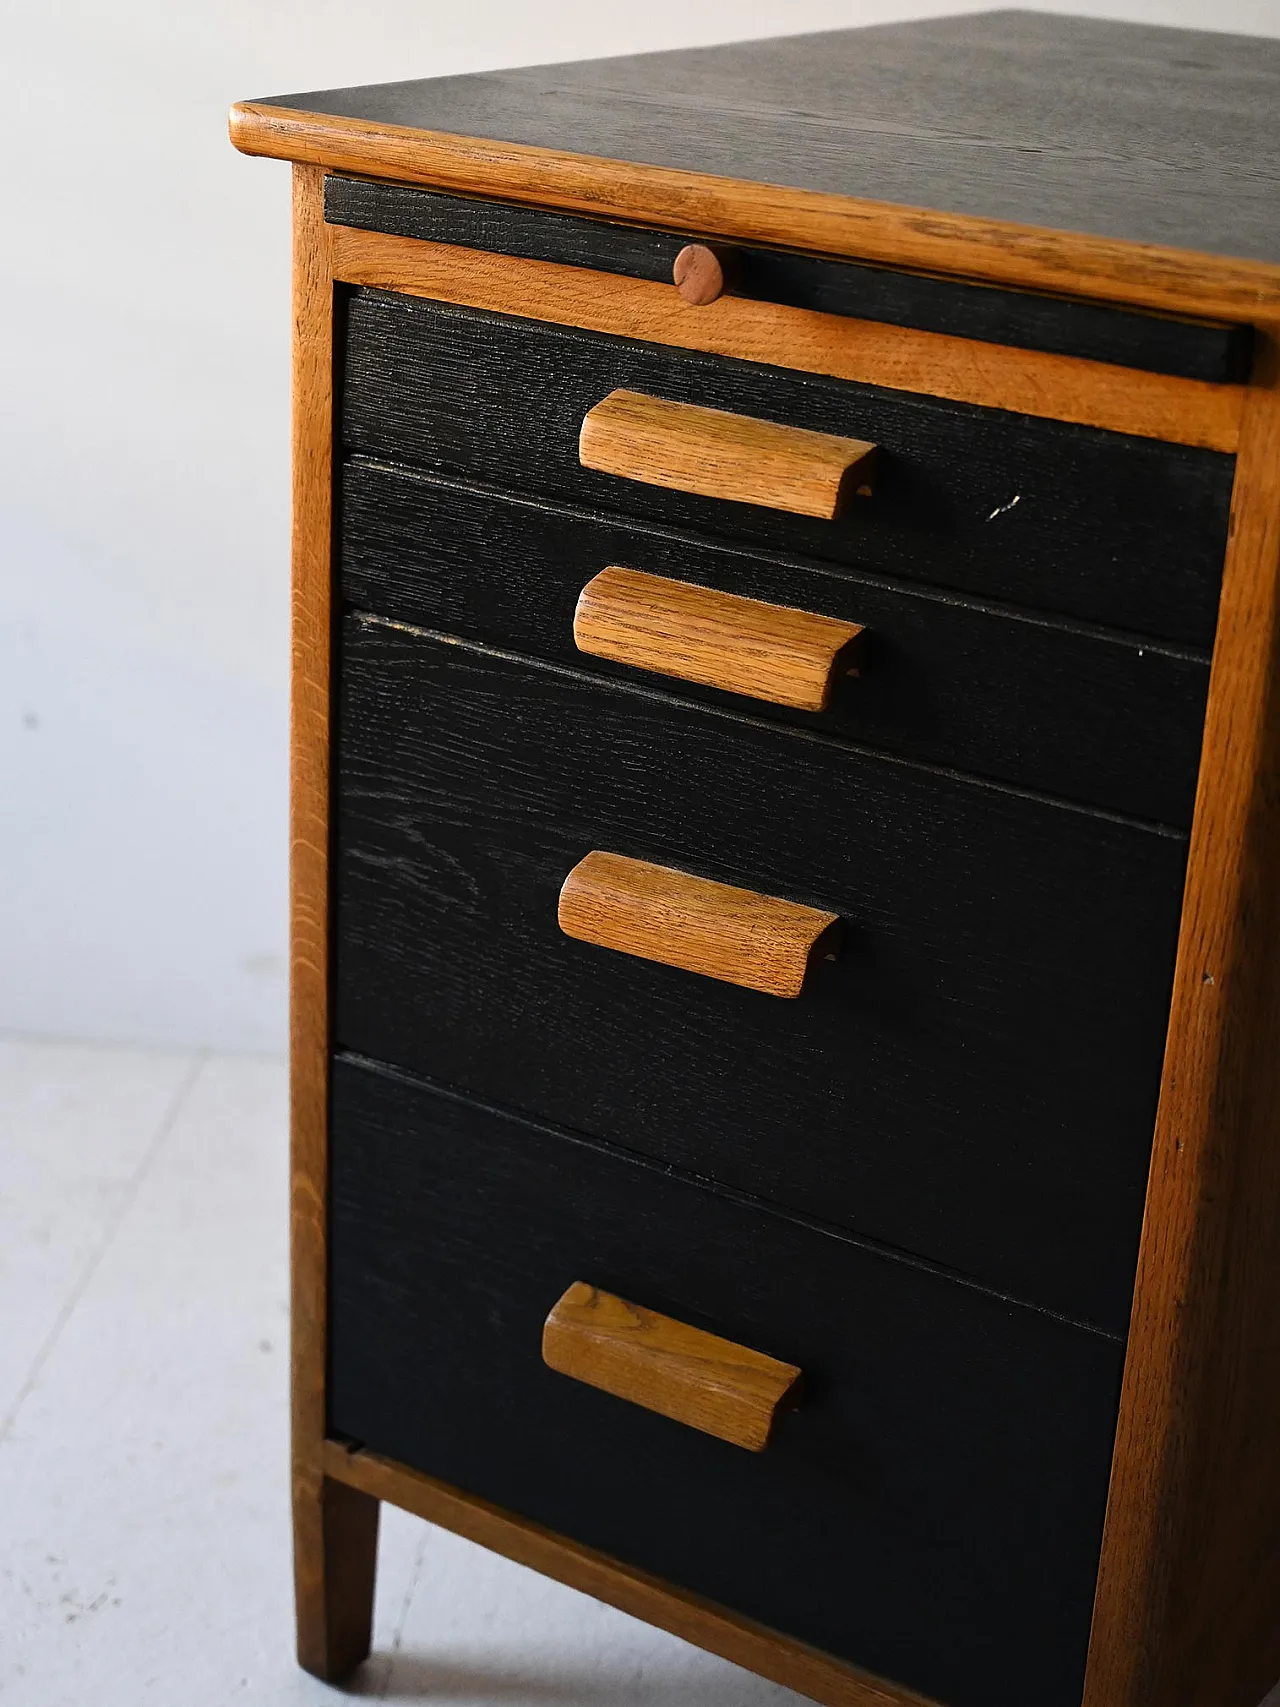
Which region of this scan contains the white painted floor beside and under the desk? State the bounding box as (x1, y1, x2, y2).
(0, 1040, 799, 1707)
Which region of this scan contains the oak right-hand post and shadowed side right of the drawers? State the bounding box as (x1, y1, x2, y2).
(1085, 336, 1280, 1707)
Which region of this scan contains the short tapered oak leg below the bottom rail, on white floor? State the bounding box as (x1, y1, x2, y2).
(294, 1477, 377, 1683)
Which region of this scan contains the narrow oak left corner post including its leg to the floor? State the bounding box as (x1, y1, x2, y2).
(288, 166, 377, 1678)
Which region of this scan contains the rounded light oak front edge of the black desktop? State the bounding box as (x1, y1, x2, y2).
(230, 101, 1280, 321)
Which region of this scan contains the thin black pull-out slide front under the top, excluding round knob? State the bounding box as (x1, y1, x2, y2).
(324, 172, 1253, 384)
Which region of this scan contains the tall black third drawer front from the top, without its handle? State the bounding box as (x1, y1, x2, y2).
(335, 618, 1186, 1333)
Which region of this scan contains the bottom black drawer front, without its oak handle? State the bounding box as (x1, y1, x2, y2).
(329, 1060, 1121, 1707)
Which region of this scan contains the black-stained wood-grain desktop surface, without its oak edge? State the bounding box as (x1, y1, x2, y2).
(262, 12, 1280, 263)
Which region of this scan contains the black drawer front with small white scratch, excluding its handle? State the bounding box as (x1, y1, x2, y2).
(341, 290, 1234, 647)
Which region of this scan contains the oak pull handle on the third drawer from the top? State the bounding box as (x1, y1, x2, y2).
(558, 852, 840, 997)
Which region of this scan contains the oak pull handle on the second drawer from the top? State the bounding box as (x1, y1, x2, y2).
(573, 568, 862, 712)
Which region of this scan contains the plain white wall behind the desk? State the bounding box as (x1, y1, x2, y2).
(0, 0, 1280, 1050)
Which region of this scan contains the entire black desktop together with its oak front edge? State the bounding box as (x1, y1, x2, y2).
(232, 12, 1280, 319)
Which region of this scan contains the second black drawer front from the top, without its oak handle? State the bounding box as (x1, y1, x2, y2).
(341, 459, 1208, 826)
